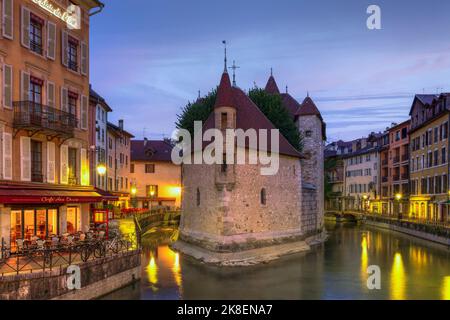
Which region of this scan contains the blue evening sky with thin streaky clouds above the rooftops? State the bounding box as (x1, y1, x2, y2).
(90, 0, 450, 141)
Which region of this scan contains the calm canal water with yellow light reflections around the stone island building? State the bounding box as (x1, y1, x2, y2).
(104, 224, 450, 300)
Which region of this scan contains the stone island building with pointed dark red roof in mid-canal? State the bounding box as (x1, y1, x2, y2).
(174, 69, 323, 264)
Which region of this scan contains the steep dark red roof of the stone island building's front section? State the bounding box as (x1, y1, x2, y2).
(203, 75, 302, 158)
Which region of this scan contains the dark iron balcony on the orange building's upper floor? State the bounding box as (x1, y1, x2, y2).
(13, 101, 78, 139)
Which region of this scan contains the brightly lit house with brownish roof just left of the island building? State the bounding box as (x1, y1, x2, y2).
(131, 139, 181, 210)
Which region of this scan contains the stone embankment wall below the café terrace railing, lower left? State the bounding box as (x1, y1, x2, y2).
(0, 250, 141, 300)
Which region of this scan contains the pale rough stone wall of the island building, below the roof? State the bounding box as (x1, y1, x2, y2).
(180, 151, 302, 251)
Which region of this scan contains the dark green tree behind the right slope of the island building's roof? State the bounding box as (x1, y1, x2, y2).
(248, 88, 303, 151)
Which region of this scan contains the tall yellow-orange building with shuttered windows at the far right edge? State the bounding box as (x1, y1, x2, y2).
(408, 94, 450, 222)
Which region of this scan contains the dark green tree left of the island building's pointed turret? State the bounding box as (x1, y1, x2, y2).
(175, 89, 217, 137)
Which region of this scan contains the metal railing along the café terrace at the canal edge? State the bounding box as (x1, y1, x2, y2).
(0, 234, 139, 277)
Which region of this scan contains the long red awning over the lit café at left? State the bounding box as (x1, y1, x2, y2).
(0, 188, 102, 204)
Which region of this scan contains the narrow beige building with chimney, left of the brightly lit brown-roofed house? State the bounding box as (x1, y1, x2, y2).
(107, 120, 134, 208)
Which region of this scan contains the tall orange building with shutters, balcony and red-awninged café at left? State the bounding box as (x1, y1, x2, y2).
(0, 0, 103, 247)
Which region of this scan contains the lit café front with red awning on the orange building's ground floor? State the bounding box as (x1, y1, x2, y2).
(0, 187, 102, 248)
